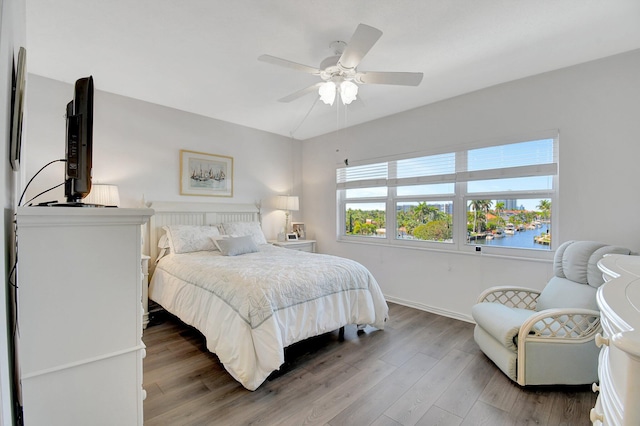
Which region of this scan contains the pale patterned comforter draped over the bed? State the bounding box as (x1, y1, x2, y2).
(149, 244, 388, 390)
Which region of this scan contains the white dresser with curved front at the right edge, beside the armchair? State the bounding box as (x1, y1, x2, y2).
(591, 255, 640, 426)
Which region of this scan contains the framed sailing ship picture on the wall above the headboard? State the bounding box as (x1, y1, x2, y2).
(180, 149, 233, 197)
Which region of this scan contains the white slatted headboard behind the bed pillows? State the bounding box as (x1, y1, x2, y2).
(145, 201, 260, 269)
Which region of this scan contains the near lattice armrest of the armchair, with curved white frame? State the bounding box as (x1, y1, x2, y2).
(518, 309, 602, 348)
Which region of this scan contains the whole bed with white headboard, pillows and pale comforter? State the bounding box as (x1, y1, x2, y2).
(145, 202, 388, 390)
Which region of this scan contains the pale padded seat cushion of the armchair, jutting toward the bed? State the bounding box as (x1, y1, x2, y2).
(471, 303, 535, 352)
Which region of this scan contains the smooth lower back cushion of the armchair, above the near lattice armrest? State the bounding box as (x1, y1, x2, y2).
(536, 277, 599, 311)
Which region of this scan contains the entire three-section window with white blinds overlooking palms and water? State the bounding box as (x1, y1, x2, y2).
(336, 134, 558, 253)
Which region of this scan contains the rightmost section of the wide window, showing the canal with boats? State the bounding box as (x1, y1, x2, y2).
(463, 139, 558, 251)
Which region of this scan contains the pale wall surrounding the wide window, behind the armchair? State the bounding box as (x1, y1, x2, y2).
(302, 51, 640, 319)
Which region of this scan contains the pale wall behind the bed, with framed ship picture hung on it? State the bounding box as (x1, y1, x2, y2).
(25, 74, 301, 238)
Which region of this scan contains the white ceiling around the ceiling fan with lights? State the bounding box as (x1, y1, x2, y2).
(26, 0, 640, 140)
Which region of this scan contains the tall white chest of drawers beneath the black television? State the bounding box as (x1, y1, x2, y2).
(17, 207, 153, 426)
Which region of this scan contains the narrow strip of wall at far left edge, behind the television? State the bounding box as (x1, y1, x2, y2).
(0, 0, 28, 425)
